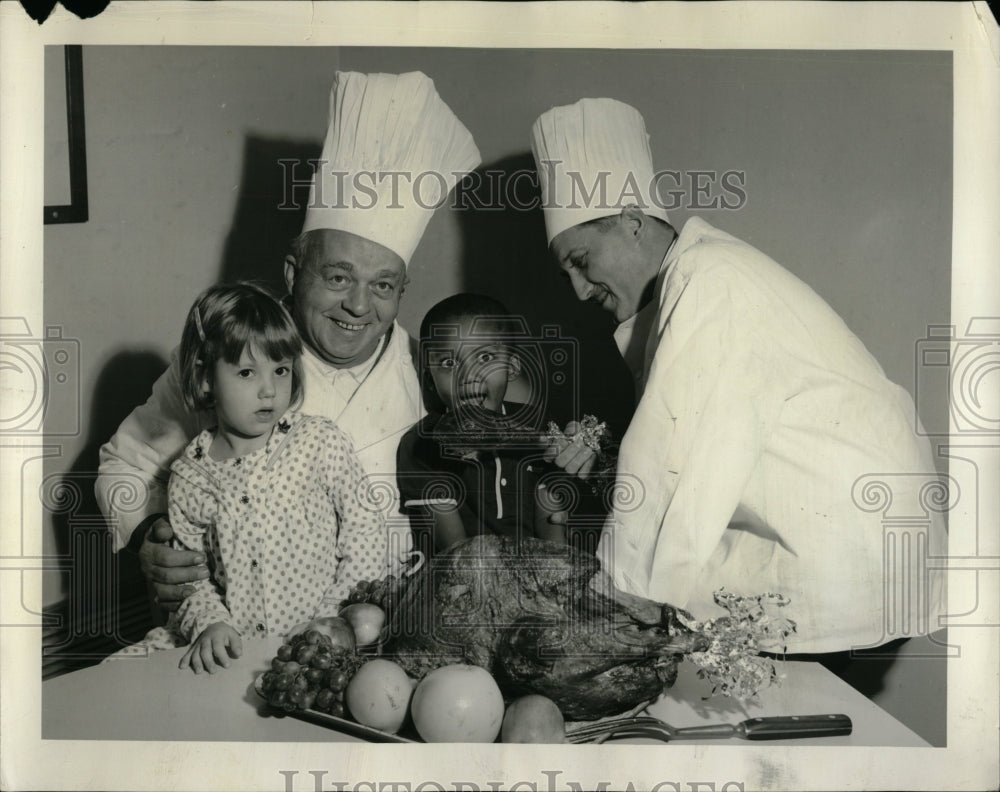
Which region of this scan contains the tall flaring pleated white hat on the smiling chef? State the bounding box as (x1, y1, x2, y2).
(302, 72, 480, 264)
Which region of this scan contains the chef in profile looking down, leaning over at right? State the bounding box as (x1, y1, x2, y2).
(532, 99, 947, 654)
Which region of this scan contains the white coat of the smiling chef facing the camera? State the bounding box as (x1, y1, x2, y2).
(96, 324, 424, 554)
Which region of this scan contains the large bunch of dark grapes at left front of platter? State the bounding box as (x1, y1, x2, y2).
(260, 630, 365, 717)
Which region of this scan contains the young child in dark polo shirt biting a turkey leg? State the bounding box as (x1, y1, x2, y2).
(397, 294, 572, 551)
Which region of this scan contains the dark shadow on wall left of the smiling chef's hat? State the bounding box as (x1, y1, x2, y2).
(219, 135, 322, 296)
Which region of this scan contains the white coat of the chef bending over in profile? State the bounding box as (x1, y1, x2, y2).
(599, 218, 947, 652)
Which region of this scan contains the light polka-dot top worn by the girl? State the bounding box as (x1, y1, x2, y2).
(117, 412, 388, 645)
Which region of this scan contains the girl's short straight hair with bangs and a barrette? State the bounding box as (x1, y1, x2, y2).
(180, 283, 302, 410)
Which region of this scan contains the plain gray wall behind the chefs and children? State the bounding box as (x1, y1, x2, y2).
(42, 47, 952, 744)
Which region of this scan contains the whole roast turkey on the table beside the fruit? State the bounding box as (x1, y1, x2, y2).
(383, 535, 711, 720)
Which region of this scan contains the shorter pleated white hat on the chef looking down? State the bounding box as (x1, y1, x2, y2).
(531, 99, 668, 243)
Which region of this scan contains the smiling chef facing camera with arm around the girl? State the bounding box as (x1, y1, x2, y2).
(96, 72, 480, 610)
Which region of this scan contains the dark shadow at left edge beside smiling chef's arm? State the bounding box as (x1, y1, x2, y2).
(42, 352, 167, 678)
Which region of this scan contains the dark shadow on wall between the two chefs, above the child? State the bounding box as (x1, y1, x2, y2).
(457, 152, 634, 439)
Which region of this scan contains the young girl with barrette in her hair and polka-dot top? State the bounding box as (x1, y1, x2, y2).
(117, 284, 387, 673)
